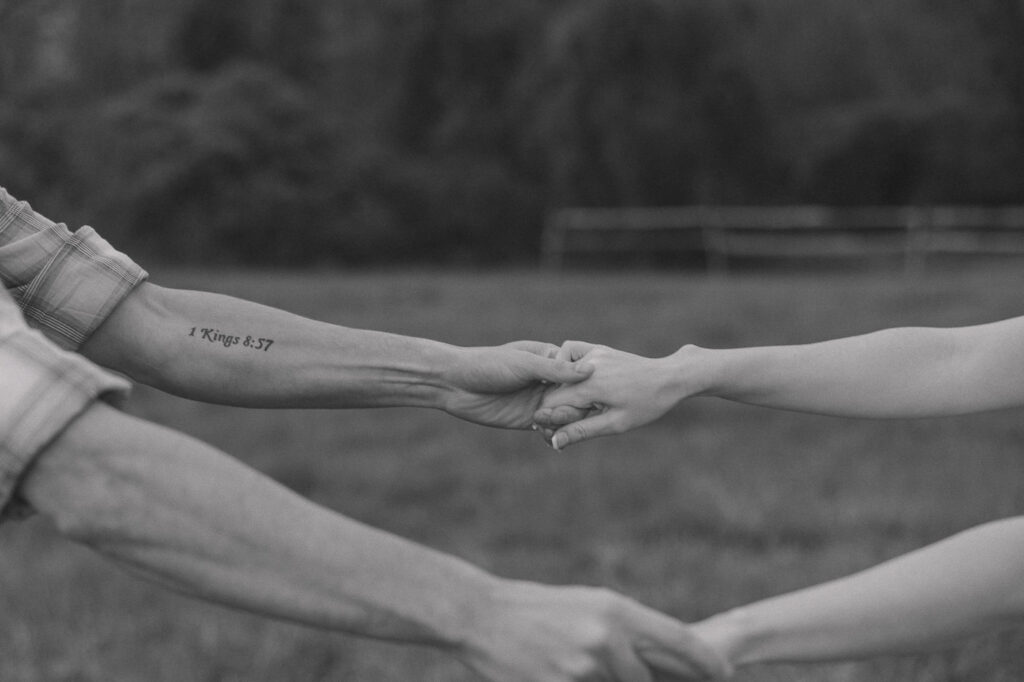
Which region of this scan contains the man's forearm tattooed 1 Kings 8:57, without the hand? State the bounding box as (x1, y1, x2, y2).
(82, 284, 456, 408)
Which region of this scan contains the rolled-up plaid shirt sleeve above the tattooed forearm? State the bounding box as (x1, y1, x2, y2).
(0, 187, 146, 350)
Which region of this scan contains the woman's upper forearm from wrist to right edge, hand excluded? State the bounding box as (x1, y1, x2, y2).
(673, 318, 1024, 417)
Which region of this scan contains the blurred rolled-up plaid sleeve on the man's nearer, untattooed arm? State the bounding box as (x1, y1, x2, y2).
(0, 291, 130, 521)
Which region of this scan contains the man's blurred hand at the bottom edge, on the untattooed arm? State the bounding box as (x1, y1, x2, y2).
(459, 582, 732, 682)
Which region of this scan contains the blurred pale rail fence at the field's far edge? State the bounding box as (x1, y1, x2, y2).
(543, 206, 1024, 270)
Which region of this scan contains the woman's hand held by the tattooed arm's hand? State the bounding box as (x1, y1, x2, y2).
(534, 341, 688, 450)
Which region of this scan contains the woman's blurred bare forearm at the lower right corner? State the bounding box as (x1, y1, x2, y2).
(694, 517, 1024, 666)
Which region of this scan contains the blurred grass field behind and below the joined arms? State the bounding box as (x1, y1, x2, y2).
(6, 261, 1024, 682)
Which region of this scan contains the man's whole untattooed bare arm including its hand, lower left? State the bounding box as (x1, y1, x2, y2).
(20, 406, 726, 682)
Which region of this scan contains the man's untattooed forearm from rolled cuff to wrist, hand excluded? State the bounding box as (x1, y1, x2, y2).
(23, 406, 496, 647)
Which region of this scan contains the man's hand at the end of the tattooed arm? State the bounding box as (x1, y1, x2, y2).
(442, 341, 591, 429)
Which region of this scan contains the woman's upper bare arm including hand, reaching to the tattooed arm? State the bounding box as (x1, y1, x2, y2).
(535, 318, 1003, 449)
